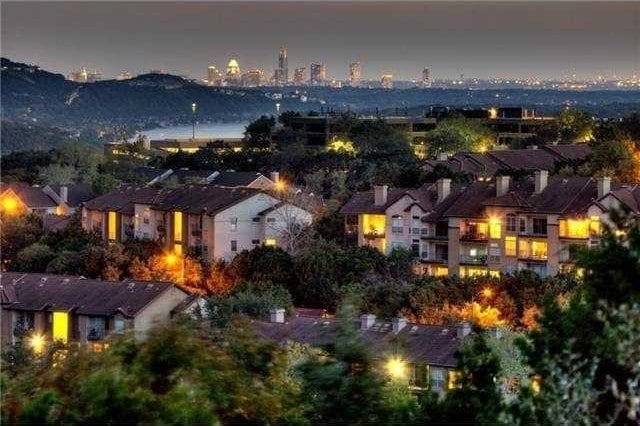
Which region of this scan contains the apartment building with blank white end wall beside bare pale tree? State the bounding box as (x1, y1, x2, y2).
(82, 185, 313, 261)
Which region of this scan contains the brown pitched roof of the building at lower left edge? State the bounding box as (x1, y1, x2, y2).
(0, 272, 186, 317)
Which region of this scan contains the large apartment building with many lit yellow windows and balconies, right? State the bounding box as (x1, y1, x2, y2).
(342, 170, 640, 277)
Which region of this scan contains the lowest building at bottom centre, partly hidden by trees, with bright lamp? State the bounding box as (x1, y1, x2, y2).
(253, 309, 471, 395)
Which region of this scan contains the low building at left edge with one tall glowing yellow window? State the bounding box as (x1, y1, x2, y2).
(0, 272, 190, 351)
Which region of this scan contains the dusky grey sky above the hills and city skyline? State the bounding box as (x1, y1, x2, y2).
(0, 1, 640, 80)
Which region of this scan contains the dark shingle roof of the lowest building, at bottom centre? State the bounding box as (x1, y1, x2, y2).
(253, 316, 462, 368)
